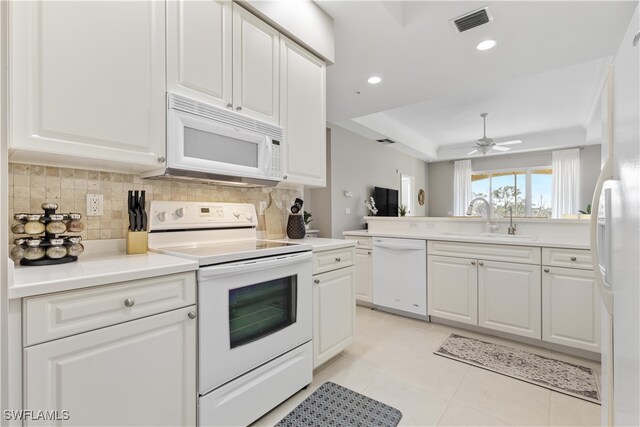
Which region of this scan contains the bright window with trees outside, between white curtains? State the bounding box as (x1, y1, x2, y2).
(471, 166, 553, 218)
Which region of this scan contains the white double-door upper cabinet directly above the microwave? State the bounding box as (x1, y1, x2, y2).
(167, 0, 280, 125)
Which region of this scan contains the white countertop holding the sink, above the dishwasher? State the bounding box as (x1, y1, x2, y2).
(342, 230, 590, 249)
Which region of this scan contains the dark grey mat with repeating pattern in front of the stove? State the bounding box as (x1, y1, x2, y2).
(276, 381, 402, 427)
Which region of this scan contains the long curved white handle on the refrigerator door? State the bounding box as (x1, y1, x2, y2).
(589, 157, 613, 313)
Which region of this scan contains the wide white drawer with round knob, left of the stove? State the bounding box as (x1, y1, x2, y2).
(23, 272, 196, 346)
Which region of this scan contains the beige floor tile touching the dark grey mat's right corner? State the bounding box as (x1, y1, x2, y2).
(363, 373, 449, 426)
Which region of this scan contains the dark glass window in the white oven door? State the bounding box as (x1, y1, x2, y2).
(229, 276, 297, 348)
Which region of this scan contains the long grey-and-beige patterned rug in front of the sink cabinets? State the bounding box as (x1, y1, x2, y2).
(434, 334, 600, 403)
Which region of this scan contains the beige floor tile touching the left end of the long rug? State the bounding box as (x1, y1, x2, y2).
(387, 350, 471, 398)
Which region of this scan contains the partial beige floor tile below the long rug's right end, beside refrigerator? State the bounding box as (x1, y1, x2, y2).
(549, 392, 602, 426)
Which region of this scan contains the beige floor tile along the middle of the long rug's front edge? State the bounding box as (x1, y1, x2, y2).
(454, 367, 551, 426)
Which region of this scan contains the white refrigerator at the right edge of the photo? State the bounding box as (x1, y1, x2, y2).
(591, 6, 640, 426)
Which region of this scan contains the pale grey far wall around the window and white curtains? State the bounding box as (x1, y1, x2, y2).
(427, 145, 600, 216)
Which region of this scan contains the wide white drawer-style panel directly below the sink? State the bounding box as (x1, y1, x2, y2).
(427, 240, 540, 264)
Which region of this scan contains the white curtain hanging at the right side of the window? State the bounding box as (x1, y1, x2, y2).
(551, 148, 580, 218)
